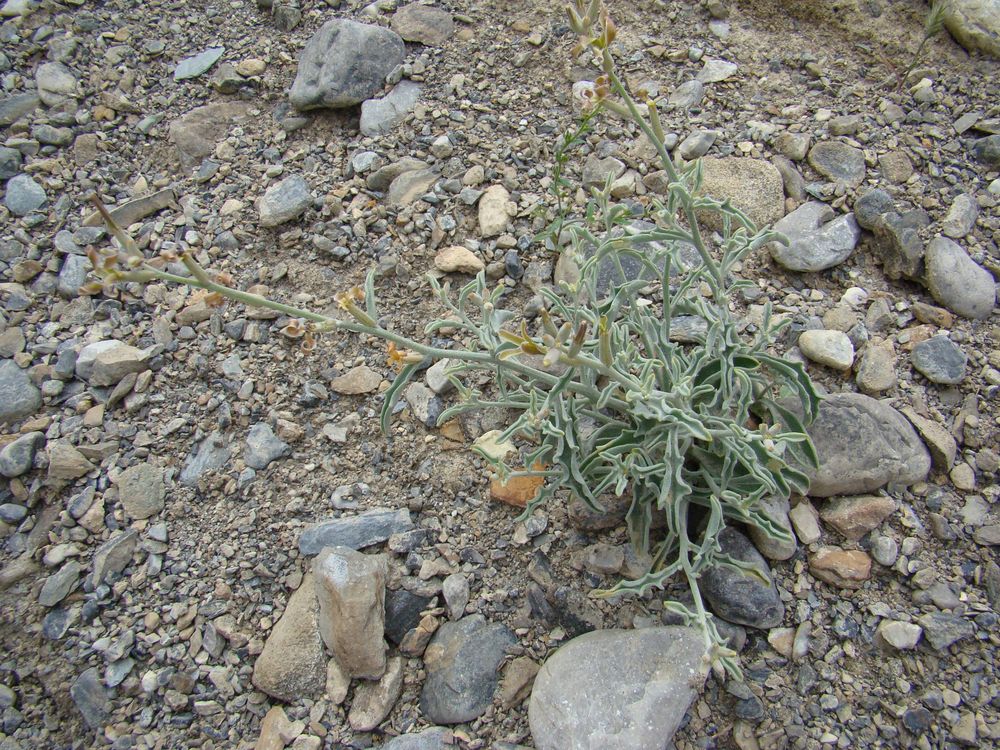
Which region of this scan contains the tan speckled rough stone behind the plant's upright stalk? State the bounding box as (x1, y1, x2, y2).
(699, 156, 785, 229)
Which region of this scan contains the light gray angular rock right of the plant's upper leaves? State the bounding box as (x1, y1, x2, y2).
(768, 201, 861, 271)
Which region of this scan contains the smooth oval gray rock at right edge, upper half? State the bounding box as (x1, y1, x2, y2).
(924, 237, 996, 319)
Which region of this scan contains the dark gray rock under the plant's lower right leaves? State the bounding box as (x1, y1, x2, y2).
(698, 528, 785, 629)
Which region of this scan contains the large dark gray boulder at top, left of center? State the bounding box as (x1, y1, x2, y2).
(289, 18, 406, 110)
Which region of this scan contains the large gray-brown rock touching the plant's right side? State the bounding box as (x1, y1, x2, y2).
(789, 393, 931, 497)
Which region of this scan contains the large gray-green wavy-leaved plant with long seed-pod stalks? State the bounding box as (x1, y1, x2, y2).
(90, 0, 818, 672)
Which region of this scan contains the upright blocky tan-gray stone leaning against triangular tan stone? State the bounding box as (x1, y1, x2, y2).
(312, 547, 389, 679)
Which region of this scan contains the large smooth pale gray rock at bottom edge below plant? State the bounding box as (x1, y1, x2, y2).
(528, 627, 706, 750)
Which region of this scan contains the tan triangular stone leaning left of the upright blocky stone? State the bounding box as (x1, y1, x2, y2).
(252, 573, 326, 701)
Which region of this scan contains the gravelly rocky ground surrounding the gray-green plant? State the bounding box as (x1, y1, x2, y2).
(0, 0, 1000, 750)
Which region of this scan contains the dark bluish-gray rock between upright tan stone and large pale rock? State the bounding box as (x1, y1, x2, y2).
(420, 615, 517, 724)
